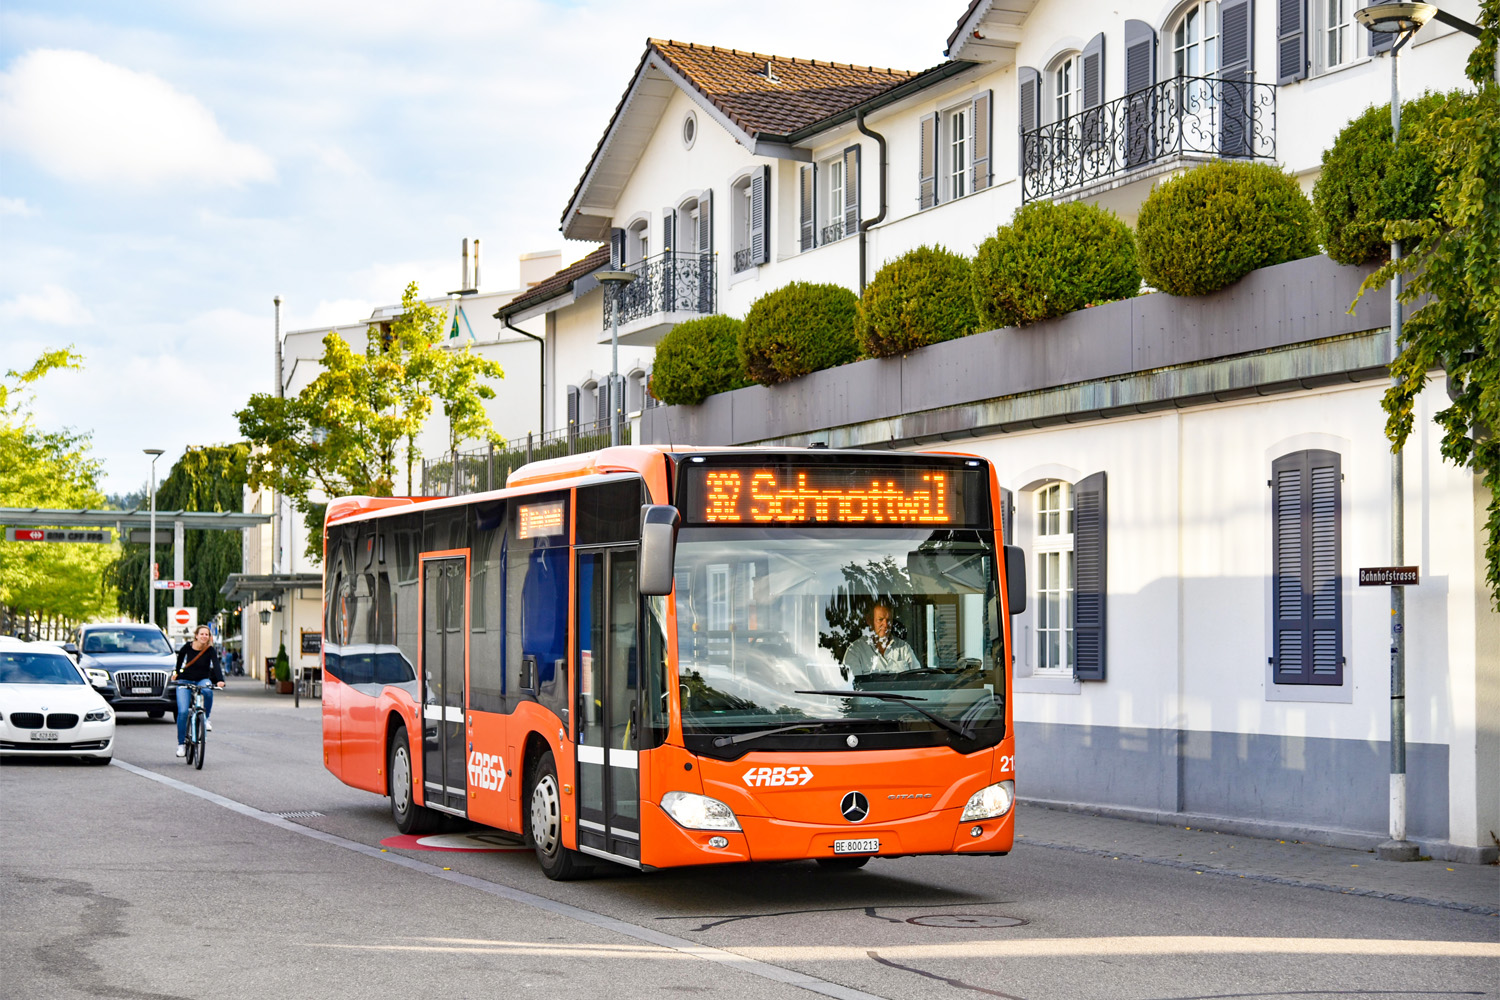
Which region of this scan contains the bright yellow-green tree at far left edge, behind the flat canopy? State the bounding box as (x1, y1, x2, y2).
(0, 346, 119, 638)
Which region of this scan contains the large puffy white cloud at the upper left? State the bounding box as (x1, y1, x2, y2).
(0, 48, 276, 187)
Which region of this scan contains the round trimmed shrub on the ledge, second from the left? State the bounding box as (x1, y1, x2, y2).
(740, 282, 860, 385)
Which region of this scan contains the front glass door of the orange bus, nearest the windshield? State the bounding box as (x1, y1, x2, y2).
(575, 546, 642, 865)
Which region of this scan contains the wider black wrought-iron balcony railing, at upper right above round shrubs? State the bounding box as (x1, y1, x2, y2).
(1022, 76, 1277, 201)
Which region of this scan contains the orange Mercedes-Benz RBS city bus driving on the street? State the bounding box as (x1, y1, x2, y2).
(323, 447, 1026, 879)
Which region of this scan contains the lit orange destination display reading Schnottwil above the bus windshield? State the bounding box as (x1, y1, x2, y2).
(681, 463, 989, 528)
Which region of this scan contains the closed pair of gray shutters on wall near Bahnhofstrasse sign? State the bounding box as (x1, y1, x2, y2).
(1271, 451, 1344, 685)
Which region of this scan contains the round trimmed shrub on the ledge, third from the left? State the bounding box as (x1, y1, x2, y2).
(854, 246, 980, 358)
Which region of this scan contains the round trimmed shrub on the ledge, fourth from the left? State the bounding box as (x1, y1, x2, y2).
(972, 201, 1140, 330)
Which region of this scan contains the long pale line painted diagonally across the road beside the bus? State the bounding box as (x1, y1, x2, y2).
(113, 757, 885, 1000)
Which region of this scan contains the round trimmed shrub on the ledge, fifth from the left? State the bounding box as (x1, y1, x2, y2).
(1136, 162, 1317, 295)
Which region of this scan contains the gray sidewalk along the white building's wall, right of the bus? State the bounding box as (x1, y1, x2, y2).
(1016, 801, 1500, 916)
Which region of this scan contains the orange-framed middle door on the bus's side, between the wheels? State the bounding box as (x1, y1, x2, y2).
(422, 556, 468, 816)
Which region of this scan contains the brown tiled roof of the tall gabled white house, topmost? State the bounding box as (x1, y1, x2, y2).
(648, 39, 917, 135)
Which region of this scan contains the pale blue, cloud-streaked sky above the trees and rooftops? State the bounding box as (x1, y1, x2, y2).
(0, 0, 968, 493)
